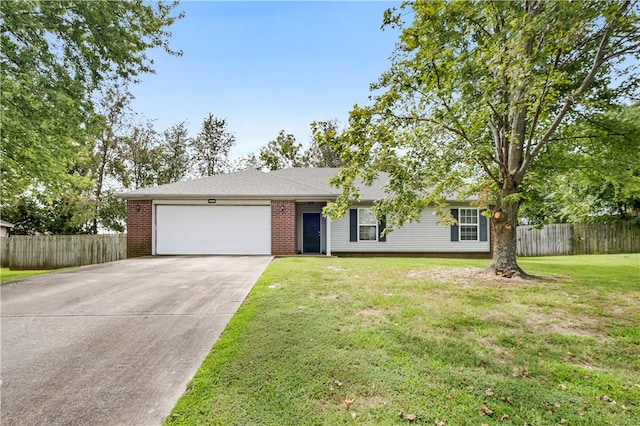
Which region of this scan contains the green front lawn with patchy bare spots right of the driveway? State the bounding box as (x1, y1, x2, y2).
(165, 254, 640, 425)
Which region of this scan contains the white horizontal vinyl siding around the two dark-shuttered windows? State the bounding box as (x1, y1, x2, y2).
(331, 206, 489, 253)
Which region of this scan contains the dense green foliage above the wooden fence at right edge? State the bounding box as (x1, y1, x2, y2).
(521, 103, 640, 224)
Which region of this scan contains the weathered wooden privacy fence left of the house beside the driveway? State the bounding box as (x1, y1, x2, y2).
(0, 234, 127, 270)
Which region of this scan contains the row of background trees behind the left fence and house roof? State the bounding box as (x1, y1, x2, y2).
(2, 83, 340, 234)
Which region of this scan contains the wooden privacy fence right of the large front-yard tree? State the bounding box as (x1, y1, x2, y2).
(517, 222, 640, 256)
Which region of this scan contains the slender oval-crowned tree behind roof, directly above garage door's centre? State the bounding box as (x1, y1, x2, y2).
(191, 113, 236, 176)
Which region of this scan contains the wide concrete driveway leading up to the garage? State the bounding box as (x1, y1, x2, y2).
(0, 256, 272, 426)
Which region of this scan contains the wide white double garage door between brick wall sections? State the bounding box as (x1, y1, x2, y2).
(156, 205, 271, 254)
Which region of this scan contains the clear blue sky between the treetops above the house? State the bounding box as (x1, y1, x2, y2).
(131, 1, 399, 157)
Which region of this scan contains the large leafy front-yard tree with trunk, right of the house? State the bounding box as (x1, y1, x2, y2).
(320, 0, 640, 276)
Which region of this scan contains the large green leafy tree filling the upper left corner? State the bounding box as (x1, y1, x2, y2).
(0, 0, 181, 203)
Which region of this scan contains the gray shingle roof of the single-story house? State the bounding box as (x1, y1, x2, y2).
(118, 168, 387, 200)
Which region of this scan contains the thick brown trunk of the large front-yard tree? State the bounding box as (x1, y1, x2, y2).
(488, 185, 526, 278)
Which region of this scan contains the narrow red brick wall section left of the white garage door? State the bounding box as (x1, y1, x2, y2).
(127, 200, 153, 258)
